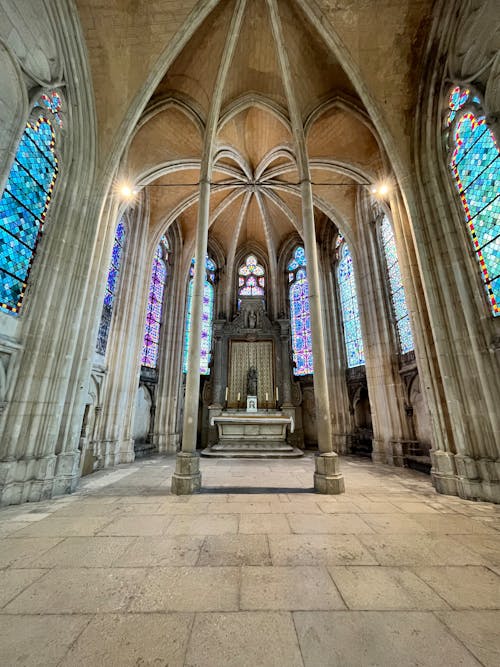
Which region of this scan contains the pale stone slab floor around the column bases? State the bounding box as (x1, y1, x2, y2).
(0, 457, 500, 667)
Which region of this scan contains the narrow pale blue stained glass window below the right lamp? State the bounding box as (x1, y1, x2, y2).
(380, 215, 414, 354)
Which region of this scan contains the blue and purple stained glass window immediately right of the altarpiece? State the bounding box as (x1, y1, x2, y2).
(288, 246, 314, 375)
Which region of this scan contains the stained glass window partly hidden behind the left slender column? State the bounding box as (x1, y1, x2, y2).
(182, 256, 217, 375)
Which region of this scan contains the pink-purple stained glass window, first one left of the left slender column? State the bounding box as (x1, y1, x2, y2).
(141, 236, 168, 368)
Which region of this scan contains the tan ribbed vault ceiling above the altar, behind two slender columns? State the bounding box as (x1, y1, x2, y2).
(127, 0, 383, 267)
